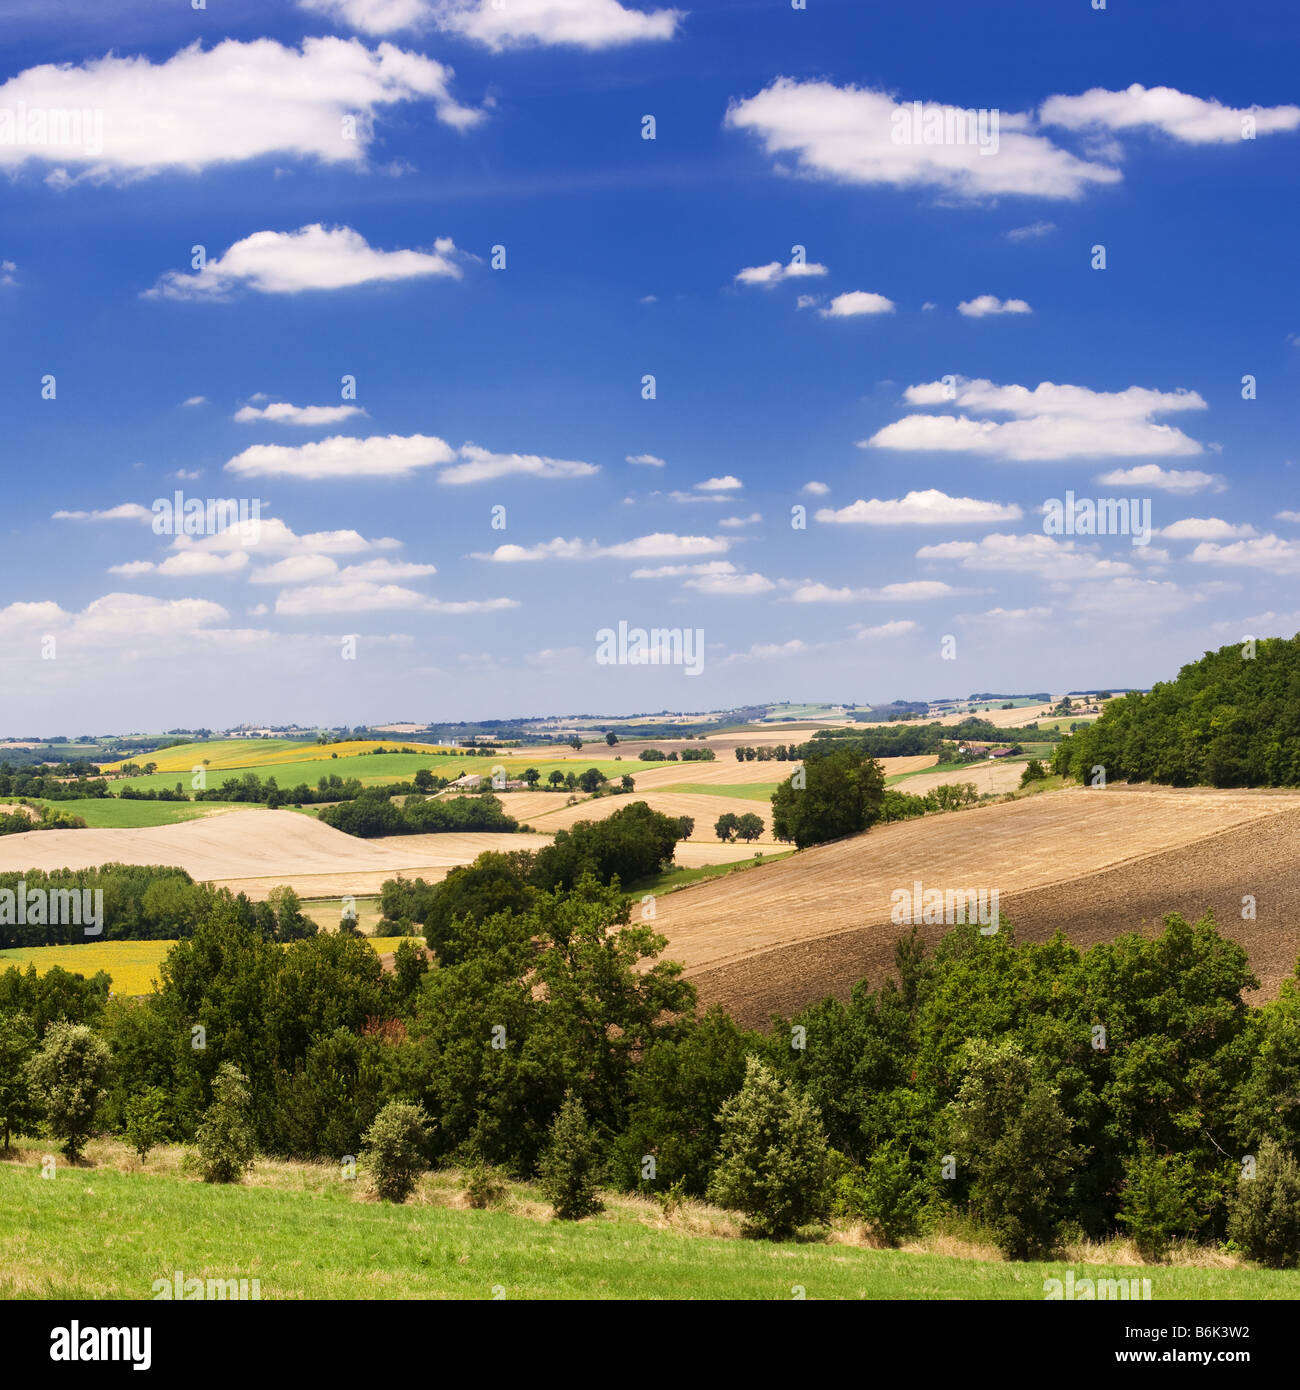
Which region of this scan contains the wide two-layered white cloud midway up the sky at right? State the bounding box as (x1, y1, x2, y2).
(859, 378, 1205, 461)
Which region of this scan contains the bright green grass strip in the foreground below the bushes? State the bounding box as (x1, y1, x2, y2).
(0, 1141, 1300, 1301)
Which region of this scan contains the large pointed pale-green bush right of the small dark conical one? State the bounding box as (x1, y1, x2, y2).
(709, 1056, 829, 1238)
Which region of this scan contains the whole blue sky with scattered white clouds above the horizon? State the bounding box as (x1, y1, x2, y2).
(0, 0, 1300, 734)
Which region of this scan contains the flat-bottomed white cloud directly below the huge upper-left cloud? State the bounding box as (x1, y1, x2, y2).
(145, 222, 460, 299)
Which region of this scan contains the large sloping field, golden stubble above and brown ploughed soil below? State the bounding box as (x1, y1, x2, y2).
(656, 787, 1300, 1024)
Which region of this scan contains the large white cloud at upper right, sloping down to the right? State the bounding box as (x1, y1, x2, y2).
(726, 78, 1121, 199)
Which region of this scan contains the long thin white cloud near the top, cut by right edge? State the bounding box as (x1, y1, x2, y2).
(1039, 82, 1300, 145)
